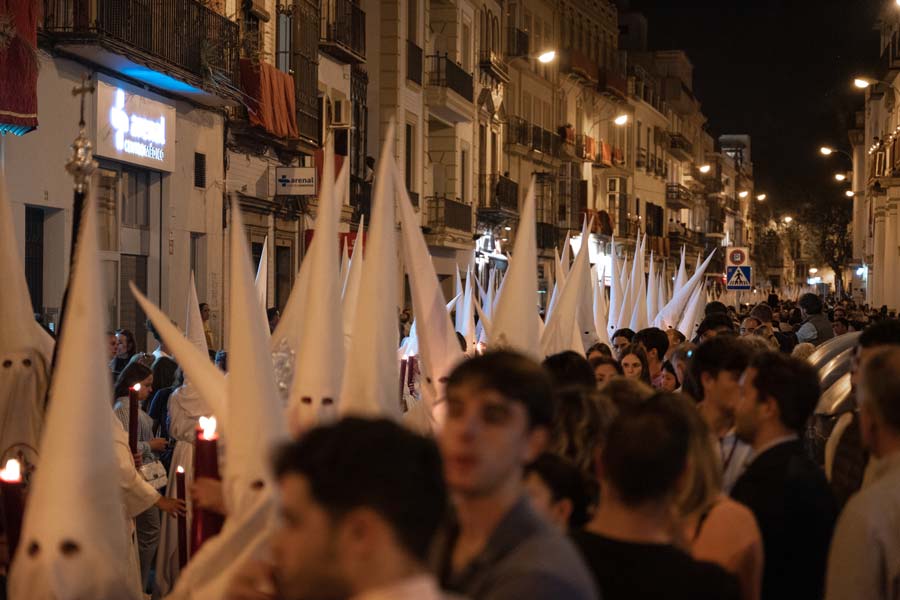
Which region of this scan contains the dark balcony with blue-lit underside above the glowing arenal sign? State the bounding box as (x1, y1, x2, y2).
(41, 0, 240, 107)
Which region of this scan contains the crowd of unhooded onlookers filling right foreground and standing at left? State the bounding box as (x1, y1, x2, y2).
(93, 294, 900, 600)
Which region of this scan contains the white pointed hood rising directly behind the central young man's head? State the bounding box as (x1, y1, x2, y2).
(491, 177, 540, 359)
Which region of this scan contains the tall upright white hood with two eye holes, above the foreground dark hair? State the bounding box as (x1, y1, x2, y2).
(288, 136, 349, 436)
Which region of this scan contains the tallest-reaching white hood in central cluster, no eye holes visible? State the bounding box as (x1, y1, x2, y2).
(338, 119, 400, 420)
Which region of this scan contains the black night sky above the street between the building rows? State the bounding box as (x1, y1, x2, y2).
(619, 0, 884, 209)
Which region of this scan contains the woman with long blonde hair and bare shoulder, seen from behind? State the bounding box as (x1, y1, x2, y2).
(670, 395, 763, 600)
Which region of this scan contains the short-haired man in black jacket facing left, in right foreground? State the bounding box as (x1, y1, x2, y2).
(731, 352, 837, 600)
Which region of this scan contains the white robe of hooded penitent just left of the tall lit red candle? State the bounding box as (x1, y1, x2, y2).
(155, 384, 222, 596)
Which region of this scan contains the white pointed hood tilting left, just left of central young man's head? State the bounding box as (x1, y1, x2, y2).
(394, 157, 463, 426)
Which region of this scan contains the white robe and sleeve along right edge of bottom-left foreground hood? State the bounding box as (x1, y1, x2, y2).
(110, 410, 159, 598)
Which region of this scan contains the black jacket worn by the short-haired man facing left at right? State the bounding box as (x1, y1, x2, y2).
(731, 440, 837, 600)
